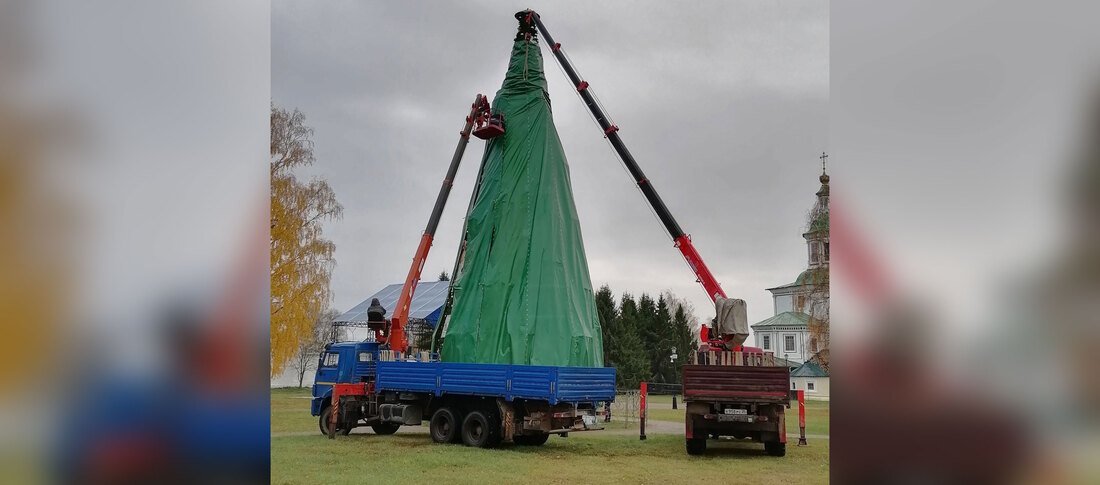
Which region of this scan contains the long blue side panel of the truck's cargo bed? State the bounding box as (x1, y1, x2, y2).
(377, 362, 615, 404)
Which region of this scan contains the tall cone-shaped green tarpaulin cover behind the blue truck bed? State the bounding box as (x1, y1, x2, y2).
(441, 40, 604, 367)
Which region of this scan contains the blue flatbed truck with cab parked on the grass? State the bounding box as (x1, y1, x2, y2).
(310, 341, 615, 448)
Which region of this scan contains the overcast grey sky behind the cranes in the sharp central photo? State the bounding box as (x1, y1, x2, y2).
(271, 1, 829, 329)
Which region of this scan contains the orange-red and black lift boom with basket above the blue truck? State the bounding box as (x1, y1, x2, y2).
(376, 95, 495, 352)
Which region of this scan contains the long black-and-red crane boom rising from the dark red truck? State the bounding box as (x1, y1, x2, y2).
(516, 10, 726, 300)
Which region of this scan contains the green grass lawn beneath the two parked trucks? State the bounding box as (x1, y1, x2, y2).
(272, 388, 829, 484)
